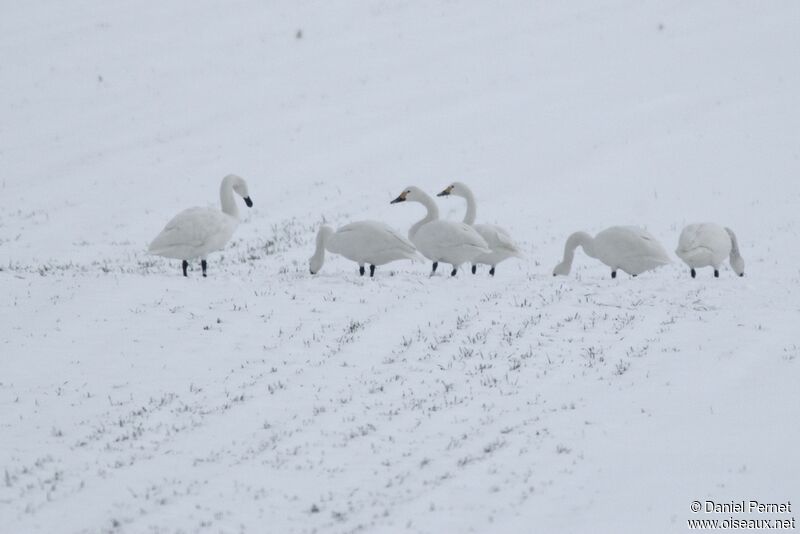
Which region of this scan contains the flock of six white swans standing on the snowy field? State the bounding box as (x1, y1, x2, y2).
(148, 178, 744, 278)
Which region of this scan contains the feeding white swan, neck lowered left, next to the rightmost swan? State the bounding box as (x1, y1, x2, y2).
(553, 226, 670, 278)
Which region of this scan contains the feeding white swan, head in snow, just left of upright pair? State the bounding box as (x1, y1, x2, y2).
(308, 221, 421, 277)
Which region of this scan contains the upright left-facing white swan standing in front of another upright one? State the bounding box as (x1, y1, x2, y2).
(390, 186, 491, 276)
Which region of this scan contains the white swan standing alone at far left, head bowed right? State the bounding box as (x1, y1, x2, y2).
(148, 174, 253, 276)
